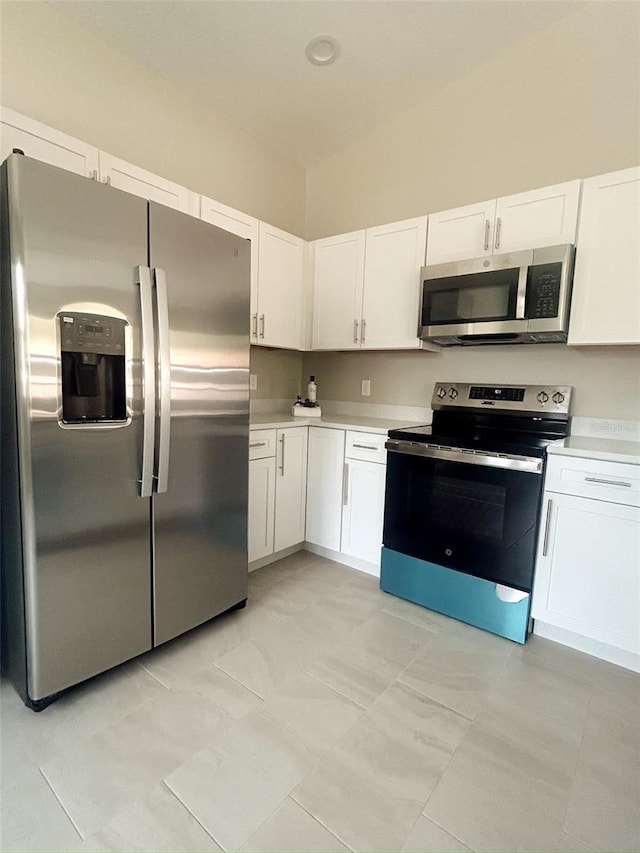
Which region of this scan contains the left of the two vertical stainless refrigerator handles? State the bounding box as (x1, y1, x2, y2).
(136, 266, 156, 498)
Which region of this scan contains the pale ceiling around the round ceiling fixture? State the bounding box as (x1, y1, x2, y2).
(50, 0, 582, 167)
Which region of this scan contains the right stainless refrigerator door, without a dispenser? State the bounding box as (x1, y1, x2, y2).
(149, 202, 250, 645)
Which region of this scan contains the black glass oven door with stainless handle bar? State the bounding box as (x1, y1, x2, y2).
(383, 441, 542, 592)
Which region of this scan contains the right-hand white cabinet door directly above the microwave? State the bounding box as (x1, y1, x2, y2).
(493, 181, 580, 254)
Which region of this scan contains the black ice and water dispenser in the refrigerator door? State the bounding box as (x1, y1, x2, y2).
(58, 312, 127, 424)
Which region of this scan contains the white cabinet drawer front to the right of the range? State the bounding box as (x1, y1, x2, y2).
(545, 455, 640, 506)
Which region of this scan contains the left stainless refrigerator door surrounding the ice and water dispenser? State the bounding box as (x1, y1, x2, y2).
(3, 155, 151, 704)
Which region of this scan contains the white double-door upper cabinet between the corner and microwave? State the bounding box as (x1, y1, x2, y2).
(312, 216, 427, 350)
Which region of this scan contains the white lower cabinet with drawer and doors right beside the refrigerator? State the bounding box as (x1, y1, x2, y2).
(248, 426, 307, 563)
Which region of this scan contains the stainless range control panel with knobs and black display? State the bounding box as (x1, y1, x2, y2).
(431, 382, 572, 415)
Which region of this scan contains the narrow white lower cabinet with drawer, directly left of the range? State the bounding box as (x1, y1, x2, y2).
(340, 431, 387, 566)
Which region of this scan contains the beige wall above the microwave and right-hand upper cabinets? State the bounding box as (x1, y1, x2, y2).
(307, 2, 640, 240)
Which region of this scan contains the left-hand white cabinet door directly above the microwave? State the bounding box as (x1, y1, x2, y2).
(427, 199, 496, 264)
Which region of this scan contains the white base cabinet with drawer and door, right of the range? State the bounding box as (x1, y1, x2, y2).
(532, 455, 640, 671)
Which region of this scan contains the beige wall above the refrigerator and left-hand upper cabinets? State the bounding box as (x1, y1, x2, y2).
(0, 0, 306, 236)
